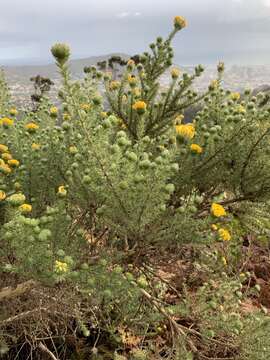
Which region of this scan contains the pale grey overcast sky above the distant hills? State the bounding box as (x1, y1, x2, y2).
(0, 0, 270, 64)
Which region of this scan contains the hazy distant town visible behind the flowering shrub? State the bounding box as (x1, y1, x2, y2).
(3, 57, 270, 106)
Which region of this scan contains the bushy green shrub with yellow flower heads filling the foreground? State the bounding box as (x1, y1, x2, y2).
(0, 17, 270, 359)
